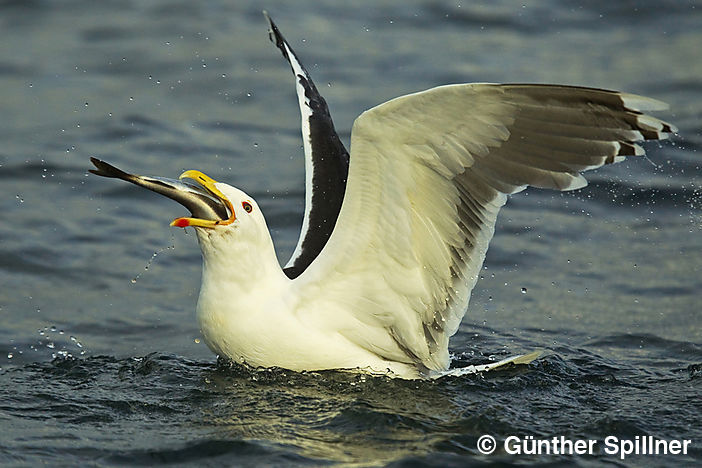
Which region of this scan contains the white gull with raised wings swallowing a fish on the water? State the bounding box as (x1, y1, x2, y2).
(91, 13, 677, 379)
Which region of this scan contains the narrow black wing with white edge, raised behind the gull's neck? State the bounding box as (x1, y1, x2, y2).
(264, 12, 349, 278)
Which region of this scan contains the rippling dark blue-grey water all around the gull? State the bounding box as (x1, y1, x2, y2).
(0, 0, 702, 466)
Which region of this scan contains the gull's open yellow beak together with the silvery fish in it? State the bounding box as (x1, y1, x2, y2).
(90, 158, 236, 228)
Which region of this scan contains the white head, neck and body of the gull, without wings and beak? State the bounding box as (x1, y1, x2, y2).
(192, 184, 419, 377)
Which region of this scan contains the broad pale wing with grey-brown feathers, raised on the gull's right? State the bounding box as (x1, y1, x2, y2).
(296, 84, 676, 371)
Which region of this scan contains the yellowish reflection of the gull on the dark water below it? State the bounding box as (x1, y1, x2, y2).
(198, 364, 464, 463)
